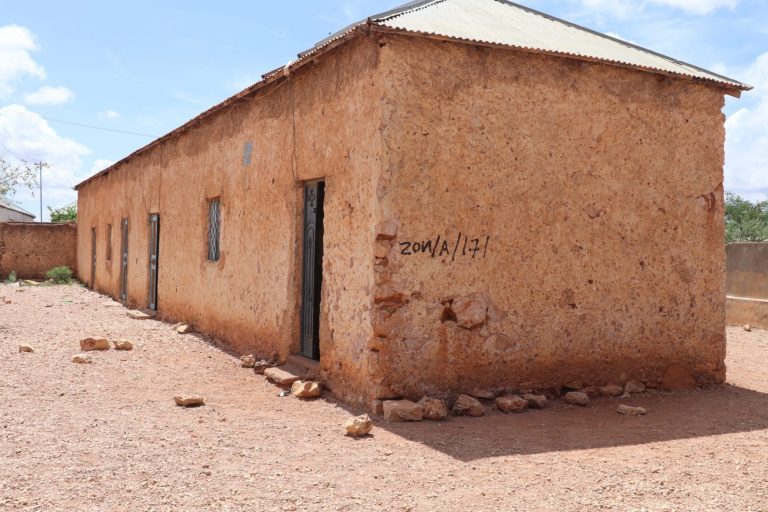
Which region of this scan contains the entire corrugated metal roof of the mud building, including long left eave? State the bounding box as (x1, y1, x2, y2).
(75, 0, 752, 189)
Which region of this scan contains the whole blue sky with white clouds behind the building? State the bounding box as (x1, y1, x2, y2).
(0, 0, 768, 220)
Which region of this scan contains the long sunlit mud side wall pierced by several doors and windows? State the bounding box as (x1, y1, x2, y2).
(78, 38, 381, 401)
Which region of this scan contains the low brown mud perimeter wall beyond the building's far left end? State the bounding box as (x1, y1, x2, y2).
(0, 222, 77, 279)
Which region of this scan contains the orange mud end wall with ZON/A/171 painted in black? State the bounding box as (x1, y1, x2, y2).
(370, 36, 725, 398)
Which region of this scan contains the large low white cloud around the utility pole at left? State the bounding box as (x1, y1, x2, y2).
(0, 105, 90, 219)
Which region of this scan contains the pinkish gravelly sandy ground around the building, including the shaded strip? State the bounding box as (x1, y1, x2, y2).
(0, 285, 768, 512)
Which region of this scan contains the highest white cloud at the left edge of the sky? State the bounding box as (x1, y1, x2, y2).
(0, 25, 45, 98)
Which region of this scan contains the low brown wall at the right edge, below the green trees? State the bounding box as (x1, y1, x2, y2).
(726, 242, 768, 329)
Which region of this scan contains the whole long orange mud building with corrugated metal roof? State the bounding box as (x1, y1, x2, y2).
(77, 0, 748, 403)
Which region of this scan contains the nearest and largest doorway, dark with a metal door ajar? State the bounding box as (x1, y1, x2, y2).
(301, 181, 325, 360)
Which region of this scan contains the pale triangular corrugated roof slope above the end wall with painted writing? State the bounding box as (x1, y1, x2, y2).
(371, 0, 750, 90)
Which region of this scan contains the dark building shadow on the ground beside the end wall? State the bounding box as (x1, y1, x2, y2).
(364, 385, 768, 461)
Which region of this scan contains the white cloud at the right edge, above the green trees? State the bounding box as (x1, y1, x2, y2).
(725, 52, 768, 200)
